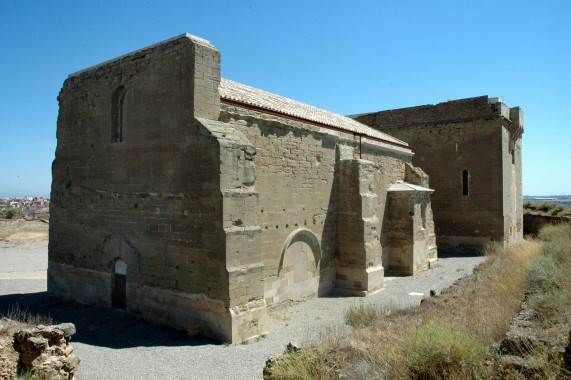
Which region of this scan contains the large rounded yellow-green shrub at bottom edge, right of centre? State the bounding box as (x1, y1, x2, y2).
(401, 320, 492, 379)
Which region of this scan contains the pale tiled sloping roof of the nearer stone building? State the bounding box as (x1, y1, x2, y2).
(218, 78, 408, 146)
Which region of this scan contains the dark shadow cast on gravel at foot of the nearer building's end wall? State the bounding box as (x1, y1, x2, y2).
(0, 292, 217, 349)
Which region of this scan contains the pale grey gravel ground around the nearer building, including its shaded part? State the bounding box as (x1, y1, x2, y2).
(0, 242, 484, 380)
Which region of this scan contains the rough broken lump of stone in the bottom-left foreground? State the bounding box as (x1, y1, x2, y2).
(14, 323, 79, 380)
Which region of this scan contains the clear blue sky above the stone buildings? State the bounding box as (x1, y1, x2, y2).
(0, 0, 571, 196)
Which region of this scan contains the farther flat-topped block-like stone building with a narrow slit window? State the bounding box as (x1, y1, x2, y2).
(351, 96, 523, 252)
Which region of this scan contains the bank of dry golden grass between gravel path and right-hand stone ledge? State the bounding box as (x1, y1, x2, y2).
(270, 241, 543, 379)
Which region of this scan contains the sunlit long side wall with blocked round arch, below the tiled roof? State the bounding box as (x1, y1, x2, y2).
(220, 104, 412, 305)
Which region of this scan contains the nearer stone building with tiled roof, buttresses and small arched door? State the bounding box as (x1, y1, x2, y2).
(48, 34, 436, 342)
